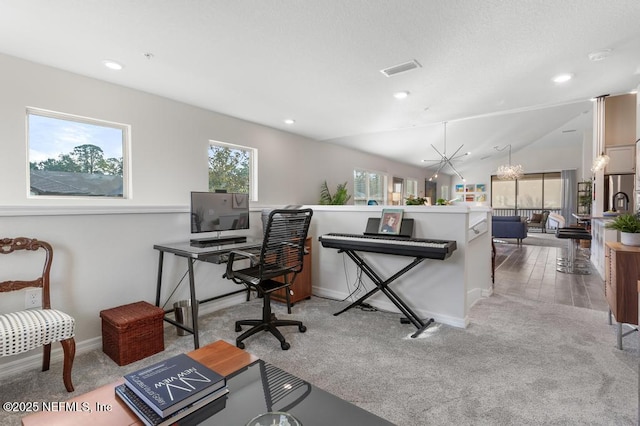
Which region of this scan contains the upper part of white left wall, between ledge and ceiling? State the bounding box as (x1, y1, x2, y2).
(0, 55, 425, 206)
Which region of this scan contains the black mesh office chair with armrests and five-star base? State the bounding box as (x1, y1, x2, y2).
(224, 209, 313, 350)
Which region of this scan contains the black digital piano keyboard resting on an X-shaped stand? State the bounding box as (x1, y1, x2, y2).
(318, 233, 456, 260)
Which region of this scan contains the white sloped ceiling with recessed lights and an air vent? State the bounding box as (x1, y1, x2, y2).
(0, 0, 640, 175)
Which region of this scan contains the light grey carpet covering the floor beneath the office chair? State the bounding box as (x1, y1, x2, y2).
(0, 295, 639, 426)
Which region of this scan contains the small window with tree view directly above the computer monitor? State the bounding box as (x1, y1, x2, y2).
(209, 141, 258, 201)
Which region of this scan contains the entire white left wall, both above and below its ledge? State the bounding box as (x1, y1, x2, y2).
(0, 51, 432, 367)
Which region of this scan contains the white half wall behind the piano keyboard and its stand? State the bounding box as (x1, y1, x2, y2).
(310, 206, 491, 327)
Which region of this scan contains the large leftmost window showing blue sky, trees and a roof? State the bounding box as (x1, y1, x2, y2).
(27, 109, 129, 198)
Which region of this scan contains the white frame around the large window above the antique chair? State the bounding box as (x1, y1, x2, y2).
(25, 107, 132, 200)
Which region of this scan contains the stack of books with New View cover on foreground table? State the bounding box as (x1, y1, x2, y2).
(115, 354, 229, 426)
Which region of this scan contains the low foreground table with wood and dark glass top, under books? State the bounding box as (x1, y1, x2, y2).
(22, 340, 393, 426)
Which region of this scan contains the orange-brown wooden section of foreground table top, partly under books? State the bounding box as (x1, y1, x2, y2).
(22, 340, 258, 426)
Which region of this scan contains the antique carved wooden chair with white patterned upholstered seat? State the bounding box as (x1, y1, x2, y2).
(0, 237, 76, 392)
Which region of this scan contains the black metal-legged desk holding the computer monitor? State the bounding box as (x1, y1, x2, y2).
(153, 237, 262, 349)
